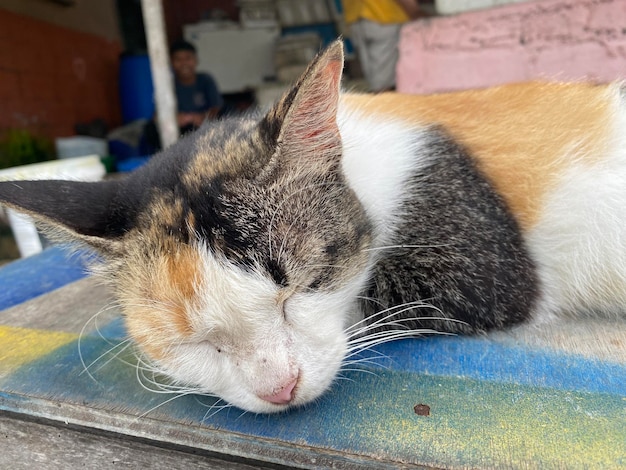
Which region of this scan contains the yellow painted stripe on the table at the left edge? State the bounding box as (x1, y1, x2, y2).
(0, 326, 78, 377)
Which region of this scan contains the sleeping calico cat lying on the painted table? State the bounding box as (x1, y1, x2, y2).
(0, 42, 626, 412)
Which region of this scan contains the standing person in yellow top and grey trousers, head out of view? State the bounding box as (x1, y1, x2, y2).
(343, 0, 420, 92)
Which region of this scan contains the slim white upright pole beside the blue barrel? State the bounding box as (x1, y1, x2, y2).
(141, 0, 178, 148)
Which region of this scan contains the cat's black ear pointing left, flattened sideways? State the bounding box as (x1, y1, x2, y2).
(0, 180, 129, 254)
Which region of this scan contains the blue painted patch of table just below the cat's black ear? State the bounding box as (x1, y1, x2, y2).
(0, 247, 94, 310)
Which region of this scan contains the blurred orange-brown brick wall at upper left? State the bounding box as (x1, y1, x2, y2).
(0, 9, 121, 137)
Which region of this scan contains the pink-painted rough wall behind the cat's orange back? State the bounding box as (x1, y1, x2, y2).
(397, 0, 626, 94)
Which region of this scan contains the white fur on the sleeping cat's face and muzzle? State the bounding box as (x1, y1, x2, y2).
(159, 247, 365, 413)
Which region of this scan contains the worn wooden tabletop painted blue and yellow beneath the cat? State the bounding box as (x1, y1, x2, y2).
(0, 248, 626, 469)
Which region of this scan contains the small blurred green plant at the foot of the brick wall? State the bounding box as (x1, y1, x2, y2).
(0, 129, 56, 169)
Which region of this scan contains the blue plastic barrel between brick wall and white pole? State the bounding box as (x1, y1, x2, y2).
(119, 54, 154, 124)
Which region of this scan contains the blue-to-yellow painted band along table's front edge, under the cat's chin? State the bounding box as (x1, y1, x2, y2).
(0, 321, 626, 469)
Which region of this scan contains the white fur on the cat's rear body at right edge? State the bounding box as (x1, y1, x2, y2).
(527, 86, 626, 322)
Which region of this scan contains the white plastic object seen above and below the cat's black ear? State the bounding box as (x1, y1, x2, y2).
(0, 155, 106, 258)
